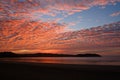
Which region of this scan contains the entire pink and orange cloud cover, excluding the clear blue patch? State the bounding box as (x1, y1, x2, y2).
(0, 0, 120, 52)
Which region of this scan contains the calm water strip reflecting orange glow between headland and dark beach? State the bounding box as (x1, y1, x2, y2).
(0, 57, 120, 65)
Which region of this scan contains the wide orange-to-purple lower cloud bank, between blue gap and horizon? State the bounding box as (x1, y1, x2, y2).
(0, 19, 120, 53)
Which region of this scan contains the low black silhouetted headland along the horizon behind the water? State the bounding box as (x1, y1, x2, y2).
(0, 52, 101, 58)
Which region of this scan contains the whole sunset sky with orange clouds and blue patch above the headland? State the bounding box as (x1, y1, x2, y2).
(0, 0, 120, 55)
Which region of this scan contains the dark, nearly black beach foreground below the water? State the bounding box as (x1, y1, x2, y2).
(0, 62, 120, 80)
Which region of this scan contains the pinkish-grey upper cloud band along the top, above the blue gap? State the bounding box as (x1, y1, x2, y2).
(0, 0, 120, 19)
